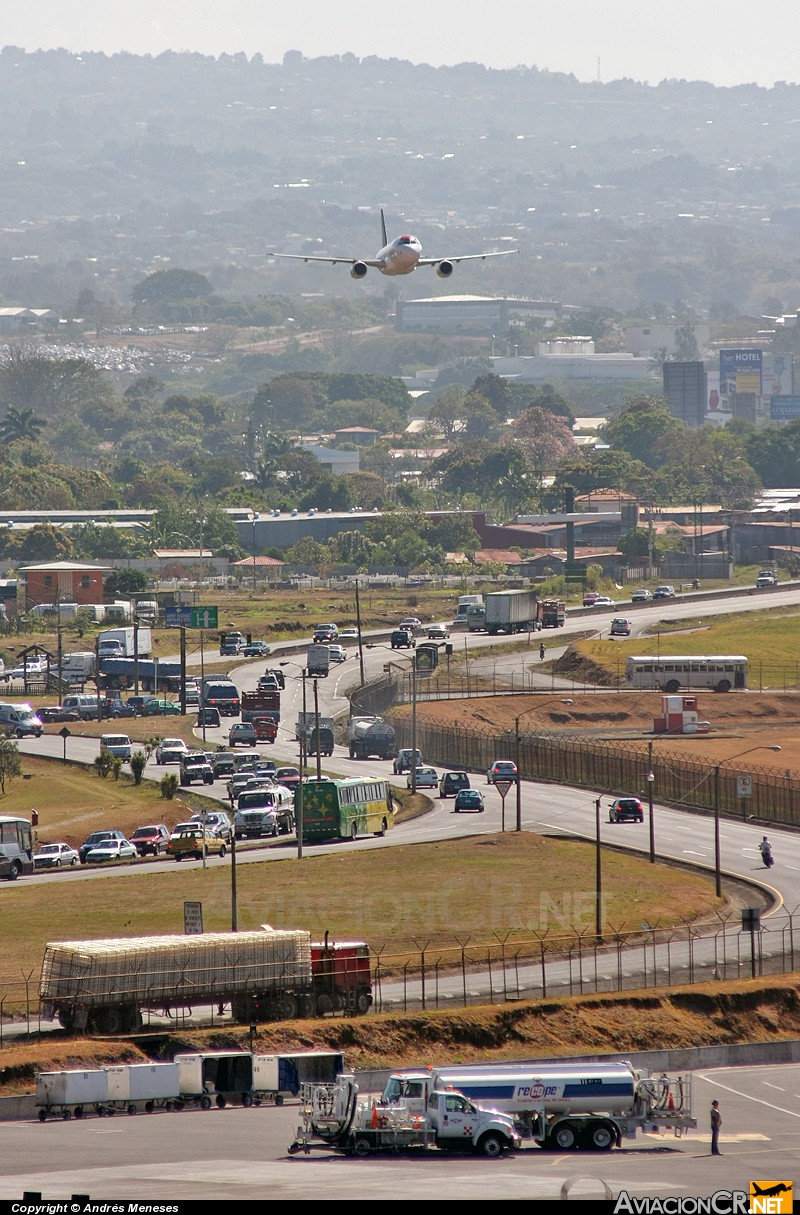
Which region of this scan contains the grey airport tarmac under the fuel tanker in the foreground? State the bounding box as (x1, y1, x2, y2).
(0, 1064, 800, 1211)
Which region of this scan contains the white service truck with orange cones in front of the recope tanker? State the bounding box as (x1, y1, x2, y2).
(289, 1074, 522, 1159)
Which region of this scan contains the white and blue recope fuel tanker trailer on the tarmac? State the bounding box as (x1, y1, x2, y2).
(382, 1062, 697, 1152)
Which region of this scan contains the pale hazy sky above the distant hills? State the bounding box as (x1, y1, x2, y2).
(6, 0, 800, 85)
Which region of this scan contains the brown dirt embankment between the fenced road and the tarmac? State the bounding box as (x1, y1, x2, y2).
(0, 978, 800, 1096)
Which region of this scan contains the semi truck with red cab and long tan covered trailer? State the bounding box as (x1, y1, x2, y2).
(39, 925, 372, 1035)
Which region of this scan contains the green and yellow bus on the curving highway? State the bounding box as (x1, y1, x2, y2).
(294, 776, 394, 843)
